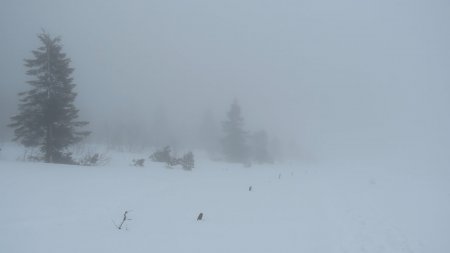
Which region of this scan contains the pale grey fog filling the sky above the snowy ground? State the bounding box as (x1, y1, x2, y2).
(0, 0, 450, 165)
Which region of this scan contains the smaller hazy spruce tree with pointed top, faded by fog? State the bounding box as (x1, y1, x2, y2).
(222, 100, 249, 163)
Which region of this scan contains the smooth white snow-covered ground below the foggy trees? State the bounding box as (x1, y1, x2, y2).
(0, 145, 450, 253)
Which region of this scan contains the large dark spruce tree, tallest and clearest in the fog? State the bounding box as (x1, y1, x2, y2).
(9, 32, 89, 163)
